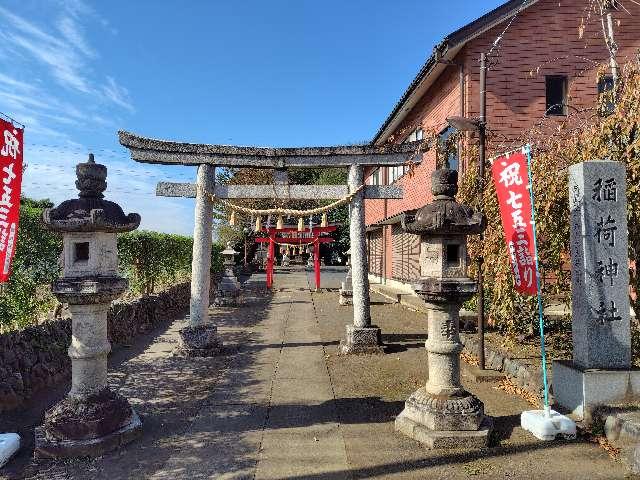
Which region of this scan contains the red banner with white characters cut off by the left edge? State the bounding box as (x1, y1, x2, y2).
(0, 118, 24, 283)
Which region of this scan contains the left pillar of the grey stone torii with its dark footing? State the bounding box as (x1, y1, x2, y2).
(179, 164, 222, 357)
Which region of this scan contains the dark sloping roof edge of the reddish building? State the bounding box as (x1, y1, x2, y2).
(371, 0, 538, 144)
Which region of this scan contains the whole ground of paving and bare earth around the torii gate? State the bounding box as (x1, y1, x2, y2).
(16, 271, 625, 480)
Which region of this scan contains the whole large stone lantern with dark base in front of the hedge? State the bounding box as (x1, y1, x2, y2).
(35, 154, 142, 457)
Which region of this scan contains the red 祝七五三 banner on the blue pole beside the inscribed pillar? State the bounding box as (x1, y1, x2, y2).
(491, 152, 537, 295)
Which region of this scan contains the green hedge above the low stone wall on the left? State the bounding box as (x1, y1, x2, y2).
(0, 198, 224, 332)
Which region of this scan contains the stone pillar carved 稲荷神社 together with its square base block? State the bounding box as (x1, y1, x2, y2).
(553, 161, 640, 423)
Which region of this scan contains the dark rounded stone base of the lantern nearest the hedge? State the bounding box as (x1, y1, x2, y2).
(35, 388, 142, 458)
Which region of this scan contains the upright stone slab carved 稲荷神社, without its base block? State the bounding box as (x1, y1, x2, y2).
(569, 161, 631, 368)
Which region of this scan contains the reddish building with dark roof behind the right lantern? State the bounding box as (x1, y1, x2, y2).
(365, 0, 640, 287)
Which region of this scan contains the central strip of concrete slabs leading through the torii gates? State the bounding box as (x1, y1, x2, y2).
(150, 273, 348, 480)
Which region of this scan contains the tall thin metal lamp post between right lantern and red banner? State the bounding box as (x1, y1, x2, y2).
(478, 53, 487, 370)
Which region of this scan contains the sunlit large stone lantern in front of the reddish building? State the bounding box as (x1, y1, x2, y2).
(396, 169, 493, 448)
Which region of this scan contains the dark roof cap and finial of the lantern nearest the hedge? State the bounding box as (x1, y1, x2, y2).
(43, 153, 140, 233)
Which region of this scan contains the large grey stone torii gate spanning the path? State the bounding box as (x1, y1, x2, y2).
(118, 131, 421, 356)
